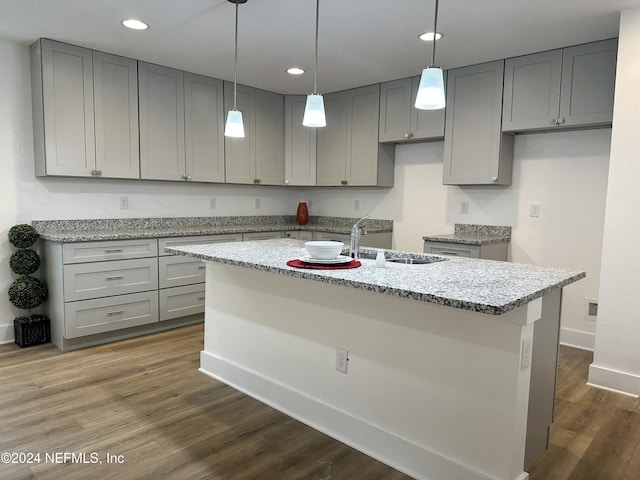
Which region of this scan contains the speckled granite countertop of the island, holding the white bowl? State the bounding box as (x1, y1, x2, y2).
(166, 239, 586, 315)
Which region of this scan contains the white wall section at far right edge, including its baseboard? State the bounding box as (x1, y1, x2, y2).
(589, 9, 640, 395)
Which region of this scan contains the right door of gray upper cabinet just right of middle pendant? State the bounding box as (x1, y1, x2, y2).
(347, 84, 380, 185)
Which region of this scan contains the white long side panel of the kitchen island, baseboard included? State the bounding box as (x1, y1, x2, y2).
(201, 262, 536, 480)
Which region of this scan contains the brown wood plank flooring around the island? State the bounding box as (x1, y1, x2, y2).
(0, 325, 640, 480)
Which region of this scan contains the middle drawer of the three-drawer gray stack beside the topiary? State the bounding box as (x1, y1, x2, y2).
(64, 258, 158, 302)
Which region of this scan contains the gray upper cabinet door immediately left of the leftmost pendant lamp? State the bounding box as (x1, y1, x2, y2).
(184, 73, 224, 182)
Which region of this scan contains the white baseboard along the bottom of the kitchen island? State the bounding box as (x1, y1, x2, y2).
(200, 351, 529, 480)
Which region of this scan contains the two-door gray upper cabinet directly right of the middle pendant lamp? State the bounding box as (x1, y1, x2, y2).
(317, 85, 395, 186)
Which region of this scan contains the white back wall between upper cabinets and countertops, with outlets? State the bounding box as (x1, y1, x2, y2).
(0, 35, 610, 348)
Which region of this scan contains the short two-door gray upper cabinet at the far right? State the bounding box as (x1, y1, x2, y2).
(502, 39, 617, 131)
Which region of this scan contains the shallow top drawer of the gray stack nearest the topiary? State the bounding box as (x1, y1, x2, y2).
(62, 238, 158, 264)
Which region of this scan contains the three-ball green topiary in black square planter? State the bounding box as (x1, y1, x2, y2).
(8, 224, 51, 347)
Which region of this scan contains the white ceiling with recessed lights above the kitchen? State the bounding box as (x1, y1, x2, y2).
(0, 0, 640, 93)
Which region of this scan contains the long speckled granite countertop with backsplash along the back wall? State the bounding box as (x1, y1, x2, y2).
(32, 215, 393, 243)
